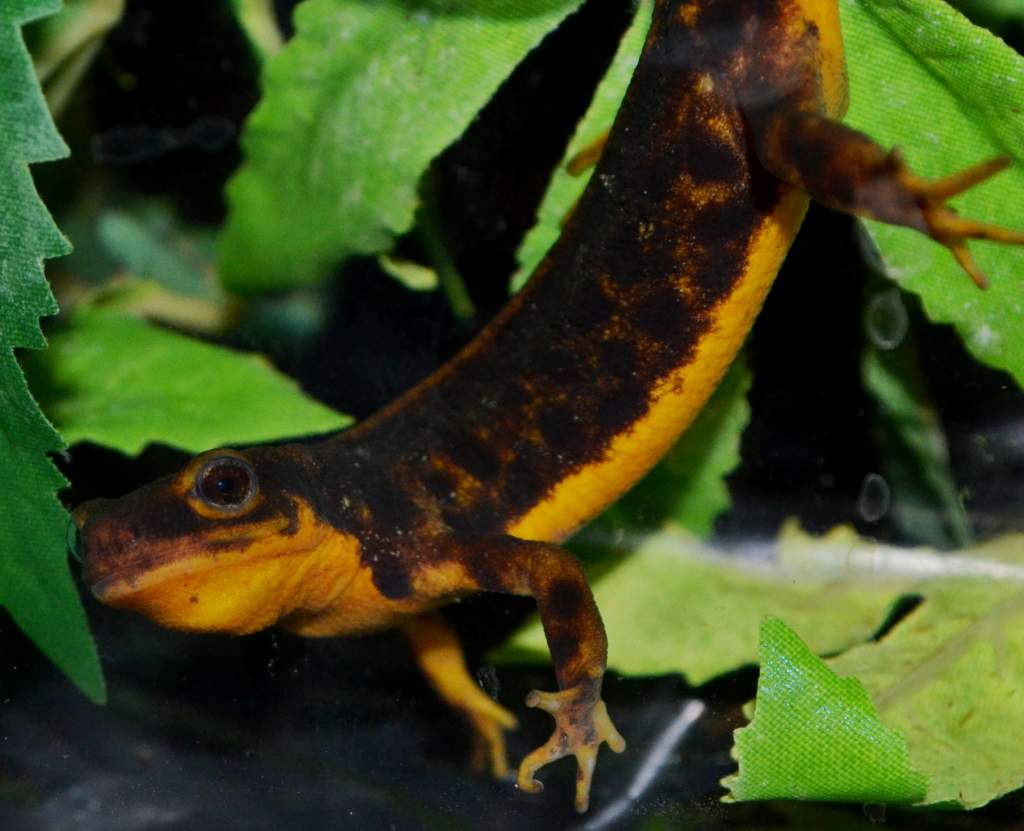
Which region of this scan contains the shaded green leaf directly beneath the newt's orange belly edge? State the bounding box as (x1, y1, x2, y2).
(605, 355, 751, 537)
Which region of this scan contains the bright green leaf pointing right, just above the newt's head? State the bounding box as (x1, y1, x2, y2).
(32, 308, 351, 453)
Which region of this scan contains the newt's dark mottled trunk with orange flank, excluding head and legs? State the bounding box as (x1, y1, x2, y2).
(324, 0, 845, 539)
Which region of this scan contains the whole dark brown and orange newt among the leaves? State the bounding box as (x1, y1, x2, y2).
(74, 0, 1024, 812)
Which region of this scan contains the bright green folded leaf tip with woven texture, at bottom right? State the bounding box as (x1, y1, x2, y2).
(722, 618, 926, 803)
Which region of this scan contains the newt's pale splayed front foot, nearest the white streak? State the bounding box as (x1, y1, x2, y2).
(516, 684, 626, 814)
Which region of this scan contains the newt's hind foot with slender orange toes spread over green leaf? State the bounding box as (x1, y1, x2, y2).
(882, 150, 1024, 289)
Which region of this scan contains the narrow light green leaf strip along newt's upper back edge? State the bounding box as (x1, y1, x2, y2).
(511, 0, 654, 291)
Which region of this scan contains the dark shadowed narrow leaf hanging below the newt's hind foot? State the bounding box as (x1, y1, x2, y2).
(861, 280, 974, 549)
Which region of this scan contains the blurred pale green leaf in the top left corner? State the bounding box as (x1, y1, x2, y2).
(26, 0, 125, 117)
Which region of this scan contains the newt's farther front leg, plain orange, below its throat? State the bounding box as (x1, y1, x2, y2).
(402, 612, 516, 779)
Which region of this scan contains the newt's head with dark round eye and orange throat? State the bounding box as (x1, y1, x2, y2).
(73, 445, 357, 633)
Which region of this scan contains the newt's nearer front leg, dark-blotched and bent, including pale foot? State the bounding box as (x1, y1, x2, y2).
(432, 537, 626, 813)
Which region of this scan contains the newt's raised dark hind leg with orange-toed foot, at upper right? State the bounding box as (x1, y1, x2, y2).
(749, 107, 1024, 289)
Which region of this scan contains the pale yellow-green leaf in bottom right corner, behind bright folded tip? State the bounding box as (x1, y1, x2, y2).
(829, 535, 1024, 807)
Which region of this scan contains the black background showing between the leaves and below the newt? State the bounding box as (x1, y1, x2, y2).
(0, 0, 1024, 831)
